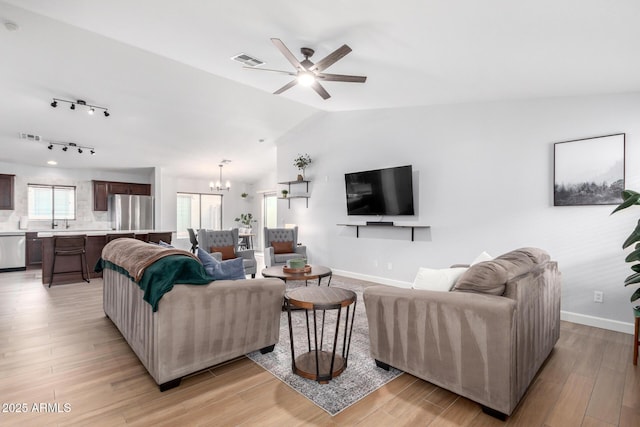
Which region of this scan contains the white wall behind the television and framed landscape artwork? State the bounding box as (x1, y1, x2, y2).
(277, 93, 640, 330)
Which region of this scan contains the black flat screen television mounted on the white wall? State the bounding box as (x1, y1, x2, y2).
(344, 165, 414, 215)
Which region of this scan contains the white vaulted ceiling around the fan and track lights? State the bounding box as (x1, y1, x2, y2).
(0, 0, 640, 182)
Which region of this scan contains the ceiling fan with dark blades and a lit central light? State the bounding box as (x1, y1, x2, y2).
(245, 39, 367, 99)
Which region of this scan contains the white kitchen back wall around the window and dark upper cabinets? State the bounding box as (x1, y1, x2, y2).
(0, 162, 152, 230)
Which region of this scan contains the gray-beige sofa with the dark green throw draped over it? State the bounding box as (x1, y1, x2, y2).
(103, 239, 285, 391)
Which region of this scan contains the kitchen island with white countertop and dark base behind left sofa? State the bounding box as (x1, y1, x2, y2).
(38, 230, 173, 285)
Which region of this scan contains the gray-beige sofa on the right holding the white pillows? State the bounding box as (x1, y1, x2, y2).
(364, 248, 560, 419)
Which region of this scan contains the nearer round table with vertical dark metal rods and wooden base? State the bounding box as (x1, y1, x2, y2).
(285, 287, 356, 384)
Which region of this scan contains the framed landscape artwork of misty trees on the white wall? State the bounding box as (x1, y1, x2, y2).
(553, 133, 625, 206)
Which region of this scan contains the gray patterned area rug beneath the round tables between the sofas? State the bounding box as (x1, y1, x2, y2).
(247, 277, 402, 415)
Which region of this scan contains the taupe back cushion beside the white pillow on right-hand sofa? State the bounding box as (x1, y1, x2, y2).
(454, 260, 508, 295)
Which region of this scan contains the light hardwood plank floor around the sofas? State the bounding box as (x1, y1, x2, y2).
(0, 270, 640, 427)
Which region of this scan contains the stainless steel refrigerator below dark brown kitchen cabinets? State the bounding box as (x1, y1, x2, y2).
(109, 194, 154, 230)
